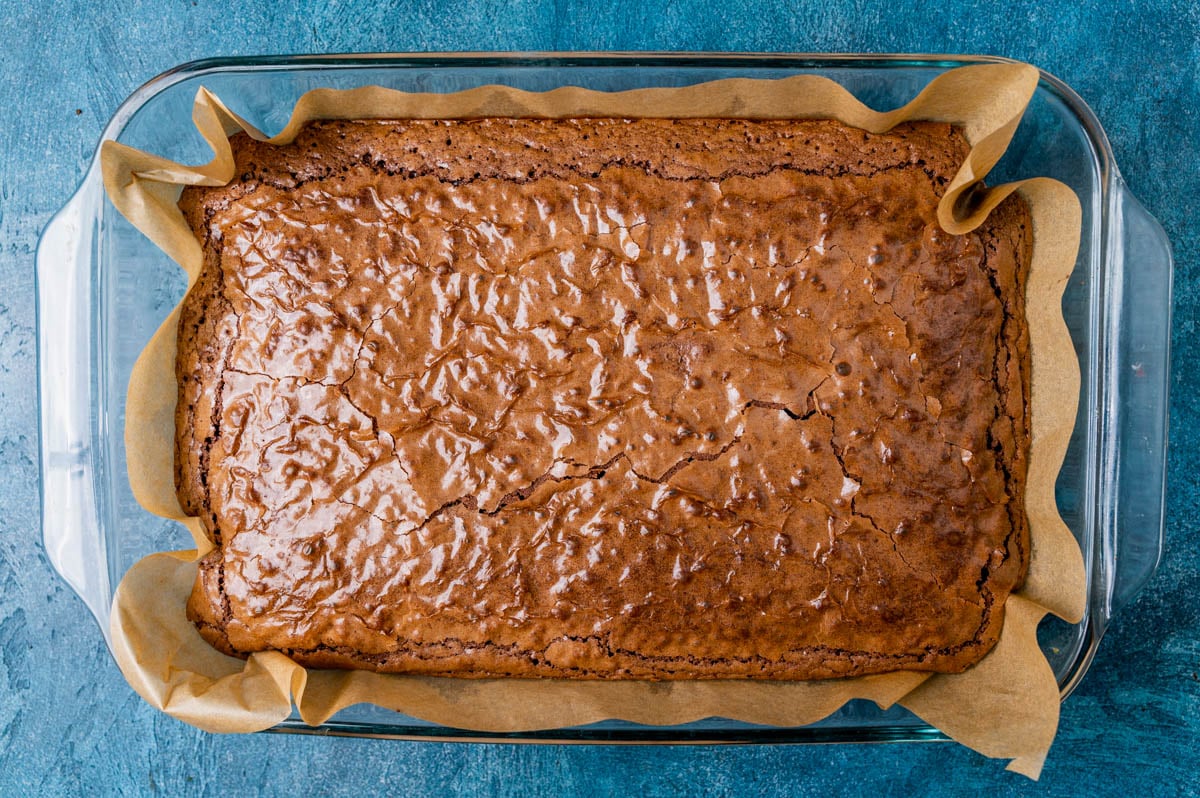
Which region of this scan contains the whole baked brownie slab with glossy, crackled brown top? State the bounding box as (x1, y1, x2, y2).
(176, 120, 1031, 679)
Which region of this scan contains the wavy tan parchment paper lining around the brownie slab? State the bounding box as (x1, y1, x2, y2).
(102, 65, 1085, 778)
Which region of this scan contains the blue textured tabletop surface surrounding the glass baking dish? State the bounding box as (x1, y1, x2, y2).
(0, 0, 1200, 796)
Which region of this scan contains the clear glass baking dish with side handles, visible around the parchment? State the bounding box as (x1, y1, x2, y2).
(37, 54, 1171, 743)
